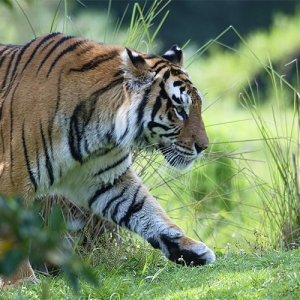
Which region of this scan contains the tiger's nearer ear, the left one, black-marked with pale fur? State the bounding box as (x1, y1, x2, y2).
(121, 48, 154, 89)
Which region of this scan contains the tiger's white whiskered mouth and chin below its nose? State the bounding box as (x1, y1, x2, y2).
(158, 145, 198, 170)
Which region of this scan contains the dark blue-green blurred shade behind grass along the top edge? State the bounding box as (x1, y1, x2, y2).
(72, 0, 299, 48)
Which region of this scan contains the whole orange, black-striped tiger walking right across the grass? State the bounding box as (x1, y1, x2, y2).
(0, 32, 216, 286)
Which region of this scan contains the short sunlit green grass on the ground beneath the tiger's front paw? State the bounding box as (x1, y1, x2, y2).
(0, 240, 300, 300)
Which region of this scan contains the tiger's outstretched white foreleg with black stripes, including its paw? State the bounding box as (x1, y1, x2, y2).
(89, 169, 215, 265)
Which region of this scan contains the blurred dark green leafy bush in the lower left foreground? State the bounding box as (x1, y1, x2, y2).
(0, 196, 98, 290)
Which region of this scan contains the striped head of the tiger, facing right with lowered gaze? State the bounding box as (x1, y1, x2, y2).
(122, 45, 208, 169)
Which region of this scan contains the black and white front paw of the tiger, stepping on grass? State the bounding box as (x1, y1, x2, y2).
(161, 236, 216, 266)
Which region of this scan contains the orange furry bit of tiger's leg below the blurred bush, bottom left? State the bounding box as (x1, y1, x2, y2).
(0, 260, 39, 290)
